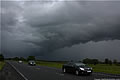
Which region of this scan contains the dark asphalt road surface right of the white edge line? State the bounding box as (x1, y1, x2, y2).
(8, 61, 120, 80)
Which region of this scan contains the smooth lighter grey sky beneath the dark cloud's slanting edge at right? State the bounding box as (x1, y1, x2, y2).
(46, 40, 120, 61)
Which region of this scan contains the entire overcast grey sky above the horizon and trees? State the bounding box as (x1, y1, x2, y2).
(0, 0, 120, 60)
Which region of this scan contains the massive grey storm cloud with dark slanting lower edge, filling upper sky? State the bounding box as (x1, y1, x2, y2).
(1, 1, 120, 55)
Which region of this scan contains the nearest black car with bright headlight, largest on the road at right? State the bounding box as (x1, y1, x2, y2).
(62, 62, 93, 75)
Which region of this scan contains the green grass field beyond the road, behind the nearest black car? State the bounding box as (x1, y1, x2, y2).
(36, 61, 120, 74)
